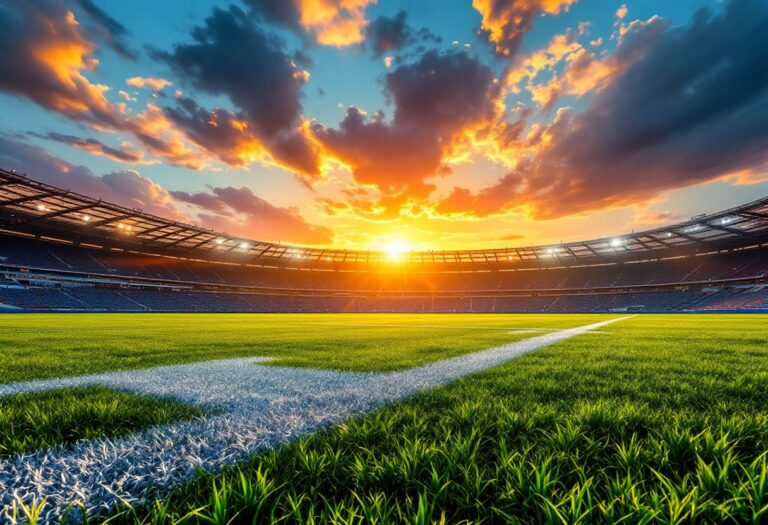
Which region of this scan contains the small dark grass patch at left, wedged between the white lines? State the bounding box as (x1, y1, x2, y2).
(0, 386, 205, 458)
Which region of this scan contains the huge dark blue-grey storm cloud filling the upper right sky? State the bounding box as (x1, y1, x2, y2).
(442, 0, 768, 218)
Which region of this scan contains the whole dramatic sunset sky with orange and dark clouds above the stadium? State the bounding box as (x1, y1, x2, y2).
(0, 0, 768, 250)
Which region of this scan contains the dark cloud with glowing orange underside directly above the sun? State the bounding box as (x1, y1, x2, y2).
(313, 51, 499, 204)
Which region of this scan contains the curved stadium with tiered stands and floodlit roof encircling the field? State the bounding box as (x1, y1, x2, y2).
(0, 169, 768, 312)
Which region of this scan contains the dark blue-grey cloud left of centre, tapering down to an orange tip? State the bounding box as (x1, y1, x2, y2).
(154, 6, 318, 176)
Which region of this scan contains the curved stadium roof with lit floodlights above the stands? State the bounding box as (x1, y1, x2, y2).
(0, 168, 768, 269)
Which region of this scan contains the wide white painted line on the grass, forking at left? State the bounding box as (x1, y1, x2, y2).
(0, 317, 626, 523)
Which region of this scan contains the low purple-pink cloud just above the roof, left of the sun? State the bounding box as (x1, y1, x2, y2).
(171, 186, 333, 244)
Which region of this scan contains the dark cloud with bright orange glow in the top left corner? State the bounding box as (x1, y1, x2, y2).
(0, 0, 203, 168)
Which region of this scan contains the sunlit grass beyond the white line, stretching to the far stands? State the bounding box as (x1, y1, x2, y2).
(0, 314, 615, 382)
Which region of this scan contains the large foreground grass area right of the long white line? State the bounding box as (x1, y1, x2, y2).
(105, 315, 768, 524)
